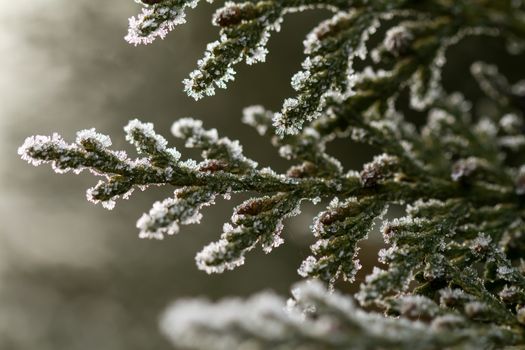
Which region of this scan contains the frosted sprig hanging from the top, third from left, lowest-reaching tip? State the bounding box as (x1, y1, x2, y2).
(274, 10, 379, 134)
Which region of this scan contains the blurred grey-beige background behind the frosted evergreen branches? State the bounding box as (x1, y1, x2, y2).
(0, 0, 519, 350)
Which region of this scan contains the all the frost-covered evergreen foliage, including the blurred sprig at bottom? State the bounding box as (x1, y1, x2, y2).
(19, 0, 525, 349)
